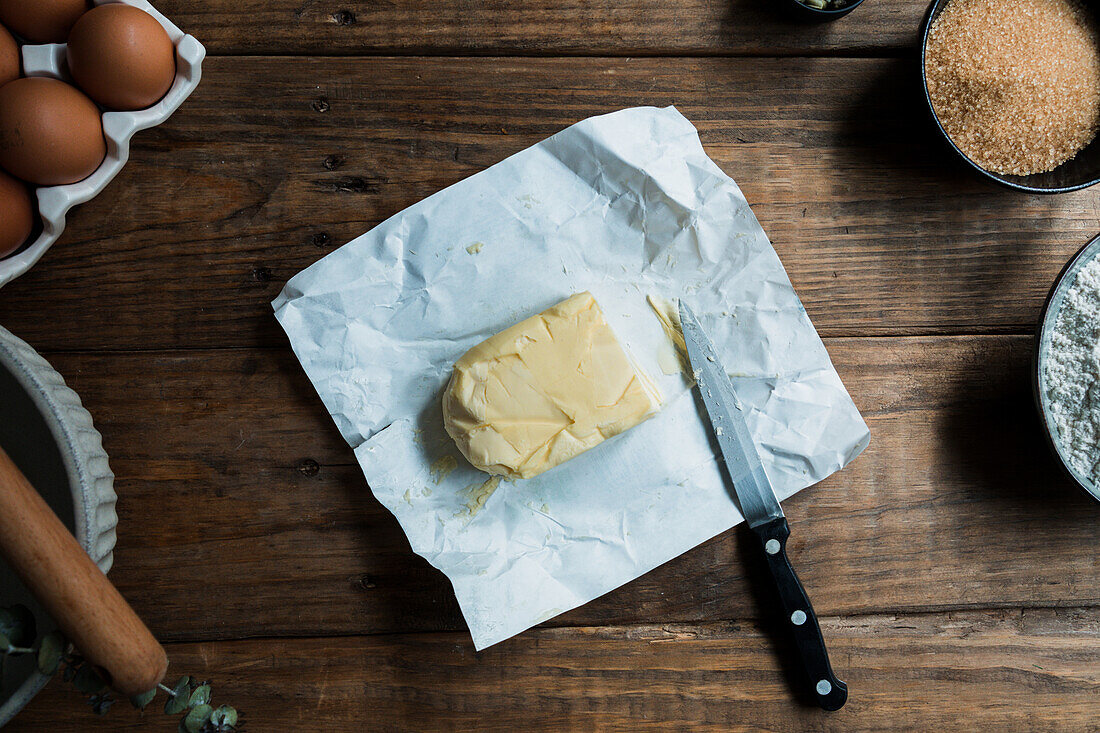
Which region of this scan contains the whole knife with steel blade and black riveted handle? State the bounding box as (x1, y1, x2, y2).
(680, 300, 848, 710)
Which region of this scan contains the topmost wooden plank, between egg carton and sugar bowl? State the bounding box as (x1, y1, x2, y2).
(157, 0, 927, 56)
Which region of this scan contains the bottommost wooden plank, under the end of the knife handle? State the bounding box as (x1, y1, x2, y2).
(9, 609, 1100, 733)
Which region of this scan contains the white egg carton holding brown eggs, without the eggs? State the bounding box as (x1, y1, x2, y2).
(0, 0, 206, 287)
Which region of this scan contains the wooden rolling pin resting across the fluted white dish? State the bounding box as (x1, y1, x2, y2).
(0, 448, 168, 697)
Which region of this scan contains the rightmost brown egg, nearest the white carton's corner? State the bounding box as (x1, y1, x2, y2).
(68, 4, 176, 110)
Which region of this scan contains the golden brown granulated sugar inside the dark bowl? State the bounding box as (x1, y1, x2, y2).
(925, 0, 1100, 175)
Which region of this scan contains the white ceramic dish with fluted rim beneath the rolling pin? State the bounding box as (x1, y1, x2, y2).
(0, 327, 118, 726)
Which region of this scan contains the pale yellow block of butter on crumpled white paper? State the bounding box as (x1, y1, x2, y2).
(443, 293, 661, 479)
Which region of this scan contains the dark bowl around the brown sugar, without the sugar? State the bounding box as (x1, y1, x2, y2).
(919, 0, 1100, 194)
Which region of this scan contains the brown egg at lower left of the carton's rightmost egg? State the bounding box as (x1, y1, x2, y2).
(0, 77, 107, 186)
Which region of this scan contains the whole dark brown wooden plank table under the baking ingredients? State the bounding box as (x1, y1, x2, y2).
(0, 0, 1100, 733)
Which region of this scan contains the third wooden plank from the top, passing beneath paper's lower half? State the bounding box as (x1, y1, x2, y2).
(19, 337, 1100, 641)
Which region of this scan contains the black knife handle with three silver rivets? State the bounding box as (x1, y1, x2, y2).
(752, 517, 848, 710)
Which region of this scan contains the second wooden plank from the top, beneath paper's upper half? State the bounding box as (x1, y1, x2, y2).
(0, 57, 1100, 350)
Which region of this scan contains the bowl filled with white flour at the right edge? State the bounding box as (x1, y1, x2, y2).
(1033, 237, 1100, 500)
